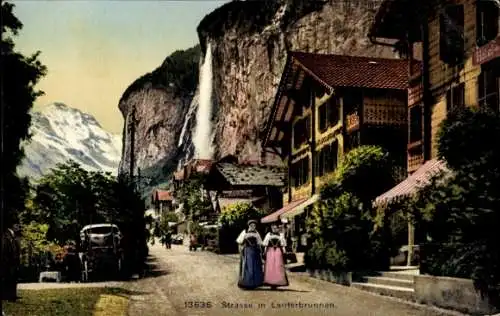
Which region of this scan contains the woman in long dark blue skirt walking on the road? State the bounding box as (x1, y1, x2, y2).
(236, 220, 264, 289)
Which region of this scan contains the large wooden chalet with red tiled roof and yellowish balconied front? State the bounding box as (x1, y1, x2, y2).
(261, 52, 409, 251)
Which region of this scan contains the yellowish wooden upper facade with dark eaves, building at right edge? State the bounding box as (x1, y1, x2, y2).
(369, 0, 500, 173)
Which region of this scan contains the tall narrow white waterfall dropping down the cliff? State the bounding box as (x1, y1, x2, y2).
(193, 42, 214, 159)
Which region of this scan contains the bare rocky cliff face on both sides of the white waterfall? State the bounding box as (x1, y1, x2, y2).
(120, 0, 396, 188)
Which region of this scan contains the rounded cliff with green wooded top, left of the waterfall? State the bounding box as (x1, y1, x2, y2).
(119, 46, 200, 184)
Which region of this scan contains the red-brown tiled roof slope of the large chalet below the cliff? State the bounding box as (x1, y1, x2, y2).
(290, 52, 408, 90)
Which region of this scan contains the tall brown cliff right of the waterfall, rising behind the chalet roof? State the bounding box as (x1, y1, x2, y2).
(199, 0, 395, 160)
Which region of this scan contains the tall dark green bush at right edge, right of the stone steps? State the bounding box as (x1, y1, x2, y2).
(411, 108, 500, 298)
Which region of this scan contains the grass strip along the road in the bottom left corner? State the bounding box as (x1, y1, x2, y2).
(4, 288, 130, 316)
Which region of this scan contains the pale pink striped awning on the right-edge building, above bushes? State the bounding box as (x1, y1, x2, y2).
(373, 159, 449, 207)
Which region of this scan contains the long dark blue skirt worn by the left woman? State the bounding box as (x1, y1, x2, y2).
(238, 246, 264, 289)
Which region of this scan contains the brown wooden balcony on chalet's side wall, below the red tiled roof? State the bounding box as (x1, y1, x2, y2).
(363, 104, 408, 125)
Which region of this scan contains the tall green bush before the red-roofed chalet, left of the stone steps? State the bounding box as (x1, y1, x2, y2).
(305, 146, 394, 271)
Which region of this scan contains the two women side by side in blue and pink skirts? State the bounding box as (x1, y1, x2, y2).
(236, 220, 289, 289)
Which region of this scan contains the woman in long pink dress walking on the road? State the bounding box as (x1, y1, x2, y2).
(263, 223, 288, 290)
